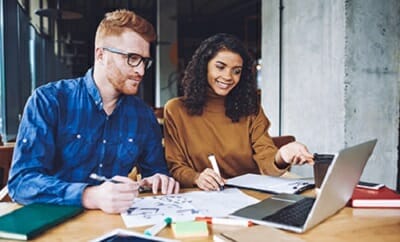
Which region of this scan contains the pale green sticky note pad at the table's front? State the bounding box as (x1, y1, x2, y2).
(171, 221, 208, 238)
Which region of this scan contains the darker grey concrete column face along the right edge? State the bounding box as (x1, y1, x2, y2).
(343, 0, 400, 189)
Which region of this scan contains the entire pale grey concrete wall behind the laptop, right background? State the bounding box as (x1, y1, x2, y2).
(262, 0, 400, 188)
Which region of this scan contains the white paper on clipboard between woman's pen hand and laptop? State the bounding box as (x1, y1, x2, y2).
(226, 173, 314, 194)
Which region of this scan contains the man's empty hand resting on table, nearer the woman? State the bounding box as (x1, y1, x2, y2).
(139, 173, 180, 194)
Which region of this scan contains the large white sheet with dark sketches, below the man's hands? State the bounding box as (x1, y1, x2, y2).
(121, 188, 259, 228)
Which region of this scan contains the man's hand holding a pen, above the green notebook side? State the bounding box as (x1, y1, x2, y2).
(82, 176, 139, 213)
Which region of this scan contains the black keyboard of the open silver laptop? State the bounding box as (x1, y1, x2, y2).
(262, 197, 315, 227)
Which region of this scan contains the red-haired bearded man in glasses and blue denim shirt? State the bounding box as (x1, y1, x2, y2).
(8, 10, 179, 213)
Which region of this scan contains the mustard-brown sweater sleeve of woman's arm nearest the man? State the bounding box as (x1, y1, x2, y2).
(164, 100, 197, 187)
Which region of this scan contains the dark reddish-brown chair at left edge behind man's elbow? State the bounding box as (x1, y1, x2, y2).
(0, 146, 14, 201)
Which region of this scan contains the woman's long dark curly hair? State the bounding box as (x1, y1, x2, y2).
(182, 33, 259, 122)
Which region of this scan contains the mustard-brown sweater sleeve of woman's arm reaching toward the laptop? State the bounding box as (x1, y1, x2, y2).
(250, 107, 290, 176)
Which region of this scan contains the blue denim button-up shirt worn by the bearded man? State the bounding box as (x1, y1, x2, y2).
(8, 70, 169, 205)
